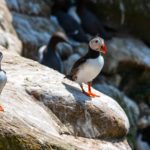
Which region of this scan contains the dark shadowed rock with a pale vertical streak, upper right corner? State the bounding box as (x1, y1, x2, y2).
(90, 0, 150, 44)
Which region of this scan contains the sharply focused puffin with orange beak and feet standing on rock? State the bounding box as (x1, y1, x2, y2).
(65, 36, 107, 97)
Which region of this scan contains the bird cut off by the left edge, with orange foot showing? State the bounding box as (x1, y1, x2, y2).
(0, 52, 7, 111)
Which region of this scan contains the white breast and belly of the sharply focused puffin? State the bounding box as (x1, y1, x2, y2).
(76, 55, 104, 83)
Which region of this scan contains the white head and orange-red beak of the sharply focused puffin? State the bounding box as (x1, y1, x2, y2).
(89, 37, 106, 54)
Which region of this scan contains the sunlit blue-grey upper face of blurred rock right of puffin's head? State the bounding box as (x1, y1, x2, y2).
(104, 38, 150, 73)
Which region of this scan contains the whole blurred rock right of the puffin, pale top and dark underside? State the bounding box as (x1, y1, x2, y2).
(103, 38, 150, 103)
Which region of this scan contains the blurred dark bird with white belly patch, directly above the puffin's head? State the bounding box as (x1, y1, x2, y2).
(68, 0, 110, 40)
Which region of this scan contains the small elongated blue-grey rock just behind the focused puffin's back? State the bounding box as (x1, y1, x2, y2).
(64, 53, 80, 75)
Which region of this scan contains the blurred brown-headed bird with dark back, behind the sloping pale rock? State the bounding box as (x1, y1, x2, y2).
(39, 32, 68, 73)
